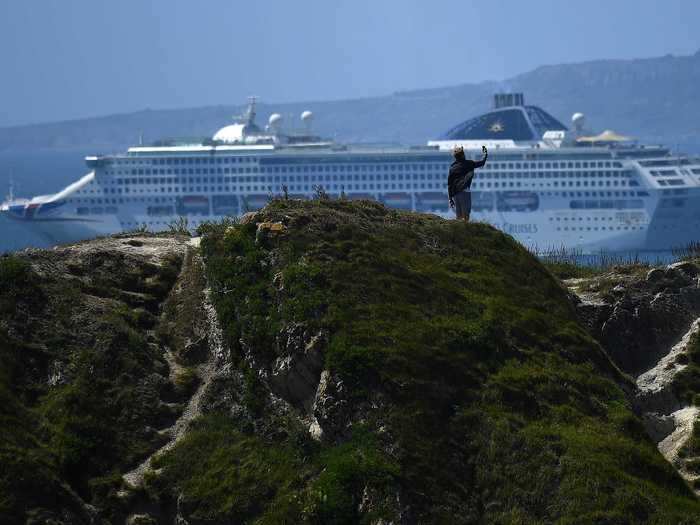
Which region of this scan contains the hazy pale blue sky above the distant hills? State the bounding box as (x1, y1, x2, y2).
(0, 0, 700, 126)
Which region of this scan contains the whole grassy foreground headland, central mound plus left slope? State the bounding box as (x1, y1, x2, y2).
(0, 199, 700, 524)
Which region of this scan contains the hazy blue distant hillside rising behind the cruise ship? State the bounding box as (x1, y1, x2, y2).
(0, 52, 700, 151)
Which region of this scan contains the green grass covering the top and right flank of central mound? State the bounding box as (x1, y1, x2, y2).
(178, 200, 700, 523)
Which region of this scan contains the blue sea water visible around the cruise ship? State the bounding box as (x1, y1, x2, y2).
(0, 145, 679, 266)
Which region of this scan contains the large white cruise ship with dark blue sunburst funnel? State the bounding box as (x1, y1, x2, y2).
(0, 93, 700, 253)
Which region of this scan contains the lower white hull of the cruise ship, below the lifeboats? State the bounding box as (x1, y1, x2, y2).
(0, 186, 700, 253)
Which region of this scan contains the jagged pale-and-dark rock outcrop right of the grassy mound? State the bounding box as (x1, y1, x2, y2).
(566, 261, 700, 492)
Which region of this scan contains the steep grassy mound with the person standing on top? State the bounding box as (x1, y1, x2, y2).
(148, 200, 700, 523)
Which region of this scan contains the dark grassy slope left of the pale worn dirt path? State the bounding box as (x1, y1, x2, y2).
(0, 242, 187, 522)
